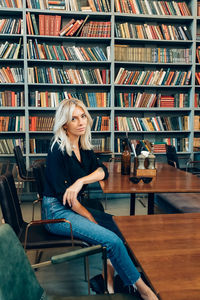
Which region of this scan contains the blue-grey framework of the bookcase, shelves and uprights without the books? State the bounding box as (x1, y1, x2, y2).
(0, 0, 200, 163)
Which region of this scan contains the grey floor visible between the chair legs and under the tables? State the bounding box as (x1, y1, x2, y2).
(0, 196, 146, 296)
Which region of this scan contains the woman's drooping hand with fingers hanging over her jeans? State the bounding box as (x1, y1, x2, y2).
(63, 179, 83, 207)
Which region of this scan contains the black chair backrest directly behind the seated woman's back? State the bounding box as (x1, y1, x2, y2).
(33, 160, 46, 198)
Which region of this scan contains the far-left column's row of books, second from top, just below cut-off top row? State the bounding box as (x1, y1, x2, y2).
(0, 18, 23, 34)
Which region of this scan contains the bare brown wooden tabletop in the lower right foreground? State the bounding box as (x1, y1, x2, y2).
(113, 213, 200, 300)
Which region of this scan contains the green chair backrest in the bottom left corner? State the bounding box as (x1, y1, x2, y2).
(0, 224, 43, 300)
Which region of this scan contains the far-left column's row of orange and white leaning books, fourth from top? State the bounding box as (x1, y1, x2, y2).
(0, 67, 24, 83)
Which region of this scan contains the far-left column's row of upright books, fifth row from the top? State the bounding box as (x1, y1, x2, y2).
(0, 91, 25, 107)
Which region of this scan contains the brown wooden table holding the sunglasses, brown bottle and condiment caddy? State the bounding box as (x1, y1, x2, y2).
(100, 162, 200, 215)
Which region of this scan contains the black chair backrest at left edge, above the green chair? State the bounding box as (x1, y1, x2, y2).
(0, 173, 24, 235)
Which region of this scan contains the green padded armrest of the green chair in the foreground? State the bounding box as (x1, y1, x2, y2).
(51, 245, 102, 264)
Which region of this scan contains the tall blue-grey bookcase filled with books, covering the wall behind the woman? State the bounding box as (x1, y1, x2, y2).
(0, 0, 200, 167)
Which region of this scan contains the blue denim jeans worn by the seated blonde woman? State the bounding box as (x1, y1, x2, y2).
(42, 196, 140, 285)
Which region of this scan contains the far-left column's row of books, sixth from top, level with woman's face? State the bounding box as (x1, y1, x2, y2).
(0, 116, 25, 131)
